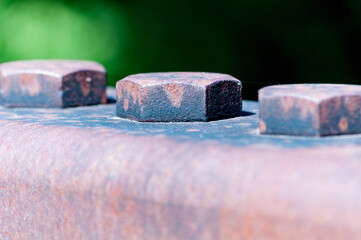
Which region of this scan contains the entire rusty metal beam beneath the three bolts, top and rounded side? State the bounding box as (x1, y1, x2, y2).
(0, 87, 361, 240)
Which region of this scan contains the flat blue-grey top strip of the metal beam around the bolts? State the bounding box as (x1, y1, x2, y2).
(0, 89, 361, 148)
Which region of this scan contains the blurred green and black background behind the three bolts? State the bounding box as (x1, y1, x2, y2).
(0, 0, 361, 99)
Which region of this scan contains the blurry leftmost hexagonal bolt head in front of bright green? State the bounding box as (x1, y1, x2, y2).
(0, 60, 107, 108)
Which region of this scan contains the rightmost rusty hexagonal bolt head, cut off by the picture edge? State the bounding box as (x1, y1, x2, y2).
(259, 84, 361, 136)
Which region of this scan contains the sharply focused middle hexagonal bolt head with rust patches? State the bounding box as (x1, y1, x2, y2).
(116, 72, 242, 122)
